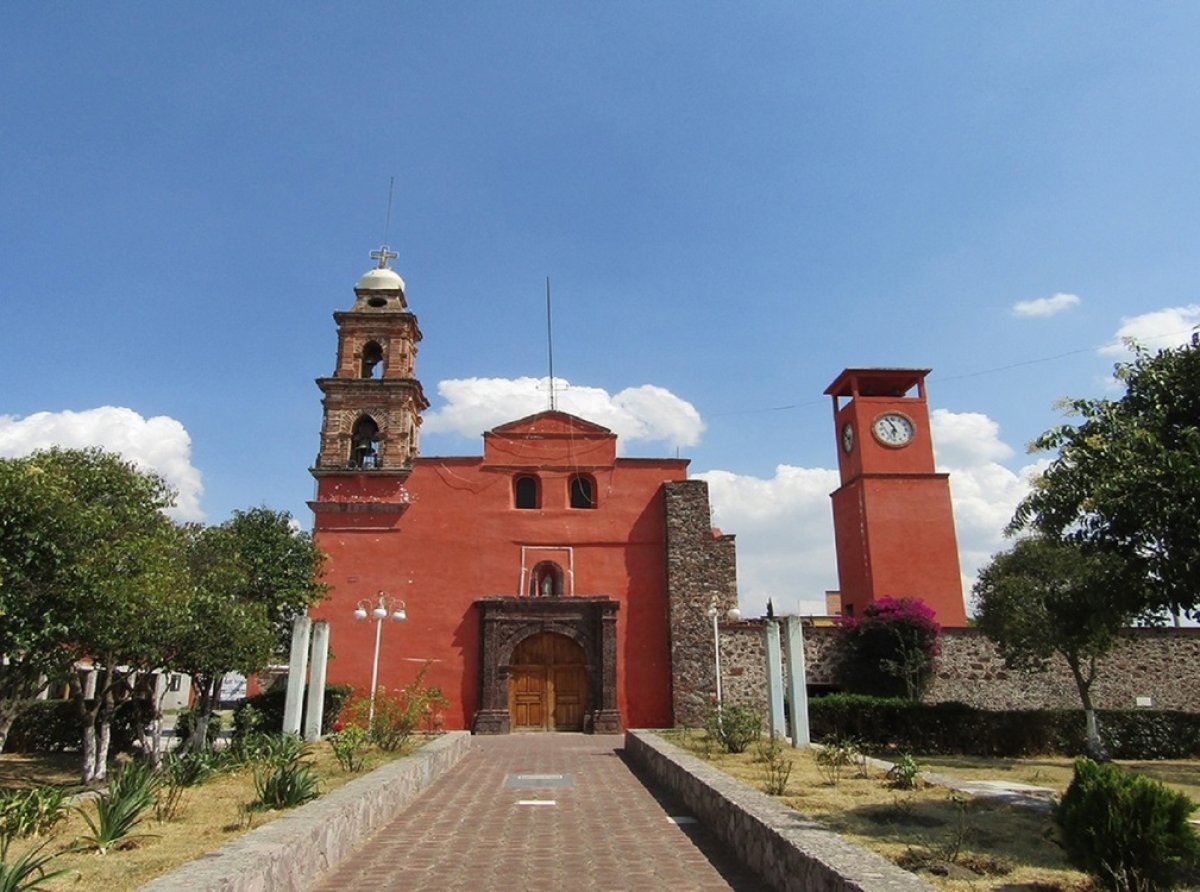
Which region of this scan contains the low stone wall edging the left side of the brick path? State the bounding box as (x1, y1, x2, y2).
(142, 731, 470, 892)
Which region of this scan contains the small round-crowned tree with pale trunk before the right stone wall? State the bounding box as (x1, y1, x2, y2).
(973, 537, 1145, 756)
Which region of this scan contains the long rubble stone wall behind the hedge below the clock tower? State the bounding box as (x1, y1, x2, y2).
(710, 619, 1200, 724)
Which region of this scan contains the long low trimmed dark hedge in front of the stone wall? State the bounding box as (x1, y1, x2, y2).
(809, 694, 1200, 759)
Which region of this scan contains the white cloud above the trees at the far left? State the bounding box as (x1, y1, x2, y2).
(0, 406, 204, 521)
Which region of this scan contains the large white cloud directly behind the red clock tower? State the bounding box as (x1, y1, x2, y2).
(697, 409, 1048, 616)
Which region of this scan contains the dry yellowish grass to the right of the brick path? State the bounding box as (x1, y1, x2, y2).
(662, 731, 1200, 892)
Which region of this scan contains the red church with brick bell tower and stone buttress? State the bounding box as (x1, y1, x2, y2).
(310, 247, 737, 734)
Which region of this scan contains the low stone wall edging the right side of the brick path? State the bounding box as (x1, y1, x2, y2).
(625, 731, 935, 892)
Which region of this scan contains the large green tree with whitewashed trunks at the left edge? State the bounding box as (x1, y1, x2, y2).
(0, 449, 181, 783)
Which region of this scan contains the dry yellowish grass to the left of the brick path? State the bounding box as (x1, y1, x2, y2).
(0, 737, 427, 892)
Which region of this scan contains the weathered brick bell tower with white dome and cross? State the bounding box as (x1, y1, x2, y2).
(310, 245, 430, 529)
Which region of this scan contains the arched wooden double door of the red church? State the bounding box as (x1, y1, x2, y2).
(509, 631, 588, 731)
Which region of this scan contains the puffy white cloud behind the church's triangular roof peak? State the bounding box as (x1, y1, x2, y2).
(421, 378, 704, 448)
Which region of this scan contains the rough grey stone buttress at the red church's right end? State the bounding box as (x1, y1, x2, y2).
(662, 480, 739, 726)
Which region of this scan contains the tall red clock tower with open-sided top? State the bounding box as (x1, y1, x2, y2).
(826, 369, 966, 627)
